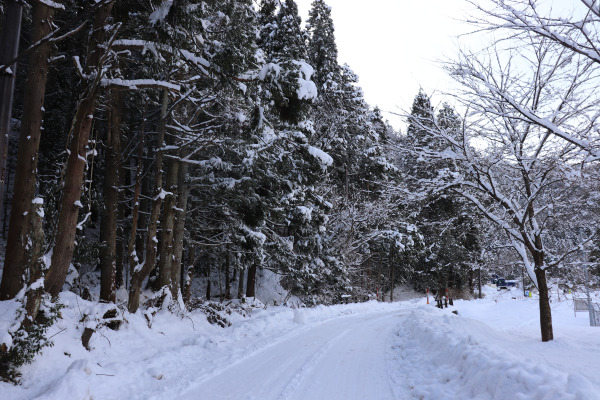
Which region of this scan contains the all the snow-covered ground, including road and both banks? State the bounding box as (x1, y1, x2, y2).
(0, 289, 600, 400)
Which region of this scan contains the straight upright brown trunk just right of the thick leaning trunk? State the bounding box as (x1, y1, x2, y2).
(100, 89, 123, 303)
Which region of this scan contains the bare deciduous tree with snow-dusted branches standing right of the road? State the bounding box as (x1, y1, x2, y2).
(411, 41, 598, 341)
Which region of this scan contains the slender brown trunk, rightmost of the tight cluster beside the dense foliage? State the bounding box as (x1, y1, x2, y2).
(171, 158, 188, 297)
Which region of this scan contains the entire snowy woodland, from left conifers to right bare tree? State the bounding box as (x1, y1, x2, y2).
(0, 0, 600, 378)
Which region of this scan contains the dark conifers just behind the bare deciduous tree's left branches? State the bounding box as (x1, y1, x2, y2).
(404, 91, 481, 290)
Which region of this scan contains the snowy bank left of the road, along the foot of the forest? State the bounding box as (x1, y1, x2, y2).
(0, 292, 407, 400)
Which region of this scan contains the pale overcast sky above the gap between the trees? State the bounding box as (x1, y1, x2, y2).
(296, 0, 478, 129)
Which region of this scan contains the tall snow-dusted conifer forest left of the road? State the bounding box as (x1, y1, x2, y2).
(0, 0, 428, 378)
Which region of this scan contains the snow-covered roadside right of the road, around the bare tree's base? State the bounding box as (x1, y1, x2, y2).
(389, 292, 600, 400)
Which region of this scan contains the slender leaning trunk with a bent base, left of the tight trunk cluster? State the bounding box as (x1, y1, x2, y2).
(128, 89, 169, 313)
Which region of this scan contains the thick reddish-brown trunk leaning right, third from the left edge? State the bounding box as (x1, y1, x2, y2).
(45, 2, 114, 297)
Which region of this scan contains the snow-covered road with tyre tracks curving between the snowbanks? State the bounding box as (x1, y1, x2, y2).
(180, 311, 401, 400)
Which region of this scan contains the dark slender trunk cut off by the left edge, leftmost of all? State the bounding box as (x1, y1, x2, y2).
(0, 0, 24, 234)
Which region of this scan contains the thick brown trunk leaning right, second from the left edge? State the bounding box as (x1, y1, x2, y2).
(0, 1, 54, 300)
